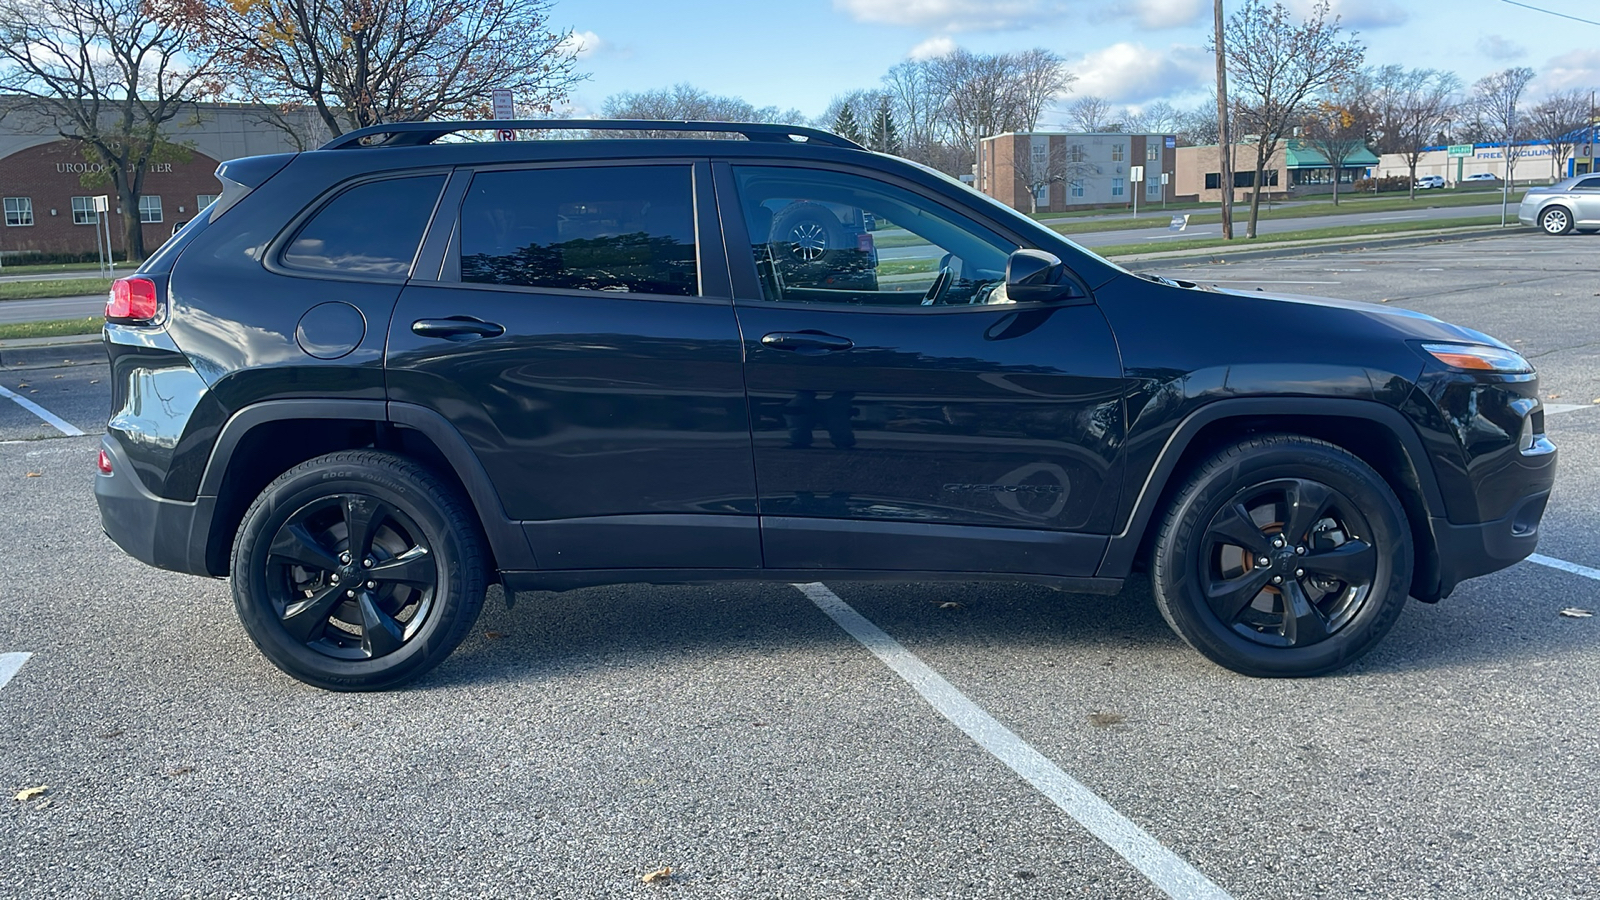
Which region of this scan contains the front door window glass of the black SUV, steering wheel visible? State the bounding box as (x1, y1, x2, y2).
(734, 167, 1011, 306)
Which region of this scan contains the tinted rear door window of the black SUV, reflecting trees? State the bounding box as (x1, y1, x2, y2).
(461, 165, 699, 296)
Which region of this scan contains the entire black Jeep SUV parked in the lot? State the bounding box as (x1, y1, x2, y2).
(96, 122, 1555, 690)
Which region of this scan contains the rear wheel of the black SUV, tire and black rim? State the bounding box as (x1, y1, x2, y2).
(232, 450, 486, 690)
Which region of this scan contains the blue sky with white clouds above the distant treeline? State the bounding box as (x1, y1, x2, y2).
(550, 0, 1600, 128)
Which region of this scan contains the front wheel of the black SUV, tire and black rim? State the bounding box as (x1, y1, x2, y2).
(1150, 434, 1413, 677)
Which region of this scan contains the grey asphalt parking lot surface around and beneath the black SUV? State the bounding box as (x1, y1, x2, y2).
(0, 234, 1600, 900)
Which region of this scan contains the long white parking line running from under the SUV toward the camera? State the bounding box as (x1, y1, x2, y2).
(795, 583, 1232, 900)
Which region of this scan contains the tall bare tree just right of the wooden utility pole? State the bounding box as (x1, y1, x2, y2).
(1224, 0, 1366, 237)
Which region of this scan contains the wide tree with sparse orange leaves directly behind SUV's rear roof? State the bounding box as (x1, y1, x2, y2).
(183, 0, 582, 135)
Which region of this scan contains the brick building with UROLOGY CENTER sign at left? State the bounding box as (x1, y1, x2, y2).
(0, 98, 322, 259)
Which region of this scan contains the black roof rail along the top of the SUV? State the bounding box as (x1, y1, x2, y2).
(318, 119, 866, 151)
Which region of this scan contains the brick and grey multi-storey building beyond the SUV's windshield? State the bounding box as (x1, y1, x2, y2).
(976, 131, 1176, 213)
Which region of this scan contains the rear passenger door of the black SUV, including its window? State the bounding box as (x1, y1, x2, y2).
(387, 160, 760, 570)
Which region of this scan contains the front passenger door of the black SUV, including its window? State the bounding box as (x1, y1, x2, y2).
(718, 163, 1125, 575)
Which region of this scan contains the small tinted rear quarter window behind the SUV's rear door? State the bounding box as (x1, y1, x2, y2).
(283, 175, 445, 277)
